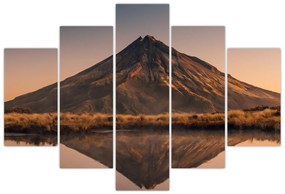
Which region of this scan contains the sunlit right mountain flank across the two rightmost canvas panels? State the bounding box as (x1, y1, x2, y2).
(172, 46, 280, 112)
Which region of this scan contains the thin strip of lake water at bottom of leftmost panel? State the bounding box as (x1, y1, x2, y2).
(4, 133, 57, 146)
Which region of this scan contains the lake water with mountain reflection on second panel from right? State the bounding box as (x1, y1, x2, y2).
(172, 130, 225, 168)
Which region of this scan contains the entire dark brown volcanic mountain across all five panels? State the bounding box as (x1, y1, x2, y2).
(5, 35, 280, 114)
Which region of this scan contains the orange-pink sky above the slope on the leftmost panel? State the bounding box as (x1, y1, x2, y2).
(4, 49, 57, 102)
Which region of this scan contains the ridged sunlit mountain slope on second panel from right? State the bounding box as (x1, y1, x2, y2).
(172, 49, 225, 112)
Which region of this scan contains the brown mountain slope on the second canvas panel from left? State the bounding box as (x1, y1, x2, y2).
(60, 54, 113, 113)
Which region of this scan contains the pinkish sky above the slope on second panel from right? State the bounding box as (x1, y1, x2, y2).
(172, 26, 225, 72)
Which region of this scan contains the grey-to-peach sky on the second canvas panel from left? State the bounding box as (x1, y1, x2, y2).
(60, 26, 113, 80)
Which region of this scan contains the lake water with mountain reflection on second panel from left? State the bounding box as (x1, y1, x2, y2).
(60, 131, 113, 168)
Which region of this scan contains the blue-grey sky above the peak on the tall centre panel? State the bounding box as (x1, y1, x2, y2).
(116, 4, 169, 53)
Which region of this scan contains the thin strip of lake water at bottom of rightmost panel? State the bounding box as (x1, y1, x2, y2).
(228, 129, 281, 146)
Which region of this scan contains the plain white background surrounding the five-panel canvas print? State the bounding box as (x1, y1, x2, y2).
(0, 0, 285, 194)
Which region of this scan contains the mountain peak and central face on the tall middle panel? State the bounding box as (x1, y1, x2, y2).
(116, 36, 169, 114)
